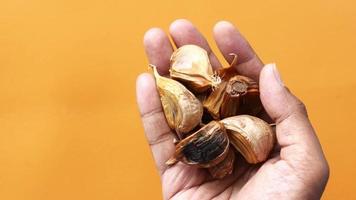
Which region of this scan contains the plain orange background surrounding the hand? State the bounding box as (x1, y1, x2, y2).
(0, 0, 356, 200)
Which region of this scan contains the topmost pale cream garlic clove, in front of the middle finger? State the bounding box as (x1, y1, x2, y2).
(170, 44, 220, 93)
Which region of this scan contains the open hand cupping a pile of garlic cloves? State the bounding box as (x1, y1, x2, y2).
(137, 20, 329, 200)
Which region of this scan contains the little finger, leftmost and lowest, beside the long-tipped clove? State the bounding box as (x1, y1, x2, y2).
(136, 73, 175, 174)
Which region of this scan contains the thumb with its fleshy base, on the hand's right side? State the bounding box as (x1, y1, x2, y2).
(260, 64, 329, 199)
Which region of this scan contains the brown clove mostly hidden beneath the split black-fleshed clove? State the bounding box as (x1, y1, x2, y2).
(208, 148, 235, 179)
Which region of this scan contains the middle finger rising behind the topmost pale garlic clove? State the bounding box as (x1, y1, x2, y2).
(169, 19, 221, 68)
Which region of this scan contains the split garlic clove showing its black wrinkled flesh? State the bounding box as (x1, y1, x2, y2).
(170, 121, 230, 168)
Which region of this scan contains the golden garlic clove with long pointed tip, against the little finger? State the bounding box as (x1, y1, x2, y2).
(153, 66, 203, 139)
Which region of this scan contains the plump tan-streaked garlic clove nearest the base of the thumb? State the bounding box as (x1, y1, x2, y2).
(220, 115, 275, 164)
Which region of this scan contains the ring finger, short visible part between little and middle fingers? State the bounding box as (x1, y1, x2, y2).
(143, 28, 173, 74)
